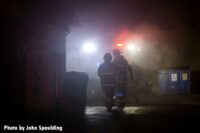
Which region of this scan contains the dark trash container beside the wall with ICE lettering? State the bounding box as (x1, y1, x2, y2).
(59, 72, 88, 114)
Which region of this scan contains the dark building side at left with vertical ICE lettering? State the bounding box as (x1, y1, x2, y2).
(0, 0, 72, 111)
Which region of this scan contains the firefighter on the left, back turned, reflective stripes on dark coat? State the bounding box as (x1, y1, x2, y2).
(98, 53, 118, 111)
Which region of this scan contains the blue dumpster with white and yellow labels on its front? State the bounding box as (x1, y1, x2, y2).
(158, 68, 190, 95)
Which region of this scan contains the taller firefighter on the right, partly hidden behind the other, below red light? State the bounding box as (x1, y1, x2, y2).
(112, 49, 133, 108)
